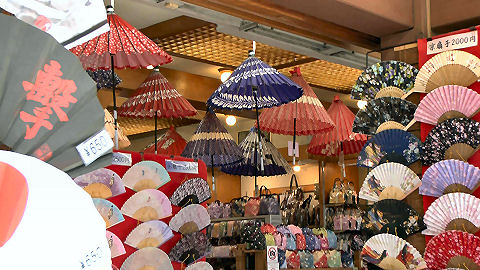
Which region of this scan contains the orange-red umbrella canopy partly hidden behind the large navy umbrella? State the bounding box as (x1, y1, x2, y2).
(259, 67, 335, 135)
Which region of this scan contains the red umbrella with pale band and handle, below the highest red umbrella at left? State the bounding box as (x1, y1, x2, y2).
(119, 68, 197, 153)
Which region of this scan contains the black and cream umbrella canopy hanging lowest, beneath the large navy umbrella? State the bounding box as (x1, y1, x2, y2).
(222, 128, 291, 176)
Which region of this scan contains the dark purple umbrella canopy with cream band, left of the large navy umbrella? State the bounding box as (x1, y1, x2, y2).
(182, 109, 243, 167)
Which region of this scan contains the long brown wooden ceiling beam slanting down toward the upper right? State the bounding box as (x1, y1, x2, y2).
(184, 0, 380, 52)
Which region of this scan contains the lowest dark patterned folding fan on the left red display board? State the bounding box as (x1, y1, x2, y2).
(169, 232, 212, 265)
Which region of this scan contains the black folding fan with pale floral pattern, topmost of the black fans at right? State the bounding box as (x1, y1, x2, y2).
(351, 61, 418, 100)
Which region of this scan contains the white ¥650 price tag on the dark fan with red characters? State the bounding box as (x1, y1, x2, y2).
(76, 129, 113, 166)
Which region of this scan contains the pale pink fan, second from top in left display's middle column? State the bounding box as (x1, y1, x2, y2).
(122, 189, 172, 222)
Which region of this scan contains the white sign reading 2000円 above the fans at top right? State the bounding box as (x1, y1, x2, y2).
(427, 31, 478, 55)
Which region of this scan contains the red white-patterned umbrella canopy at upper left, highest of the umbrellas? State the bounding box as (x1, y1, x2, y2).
(70, 6, 173, 70)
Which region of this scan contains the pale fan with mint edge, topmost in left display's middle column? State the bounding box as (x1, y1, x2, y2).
(122, 160, 170, 191)
